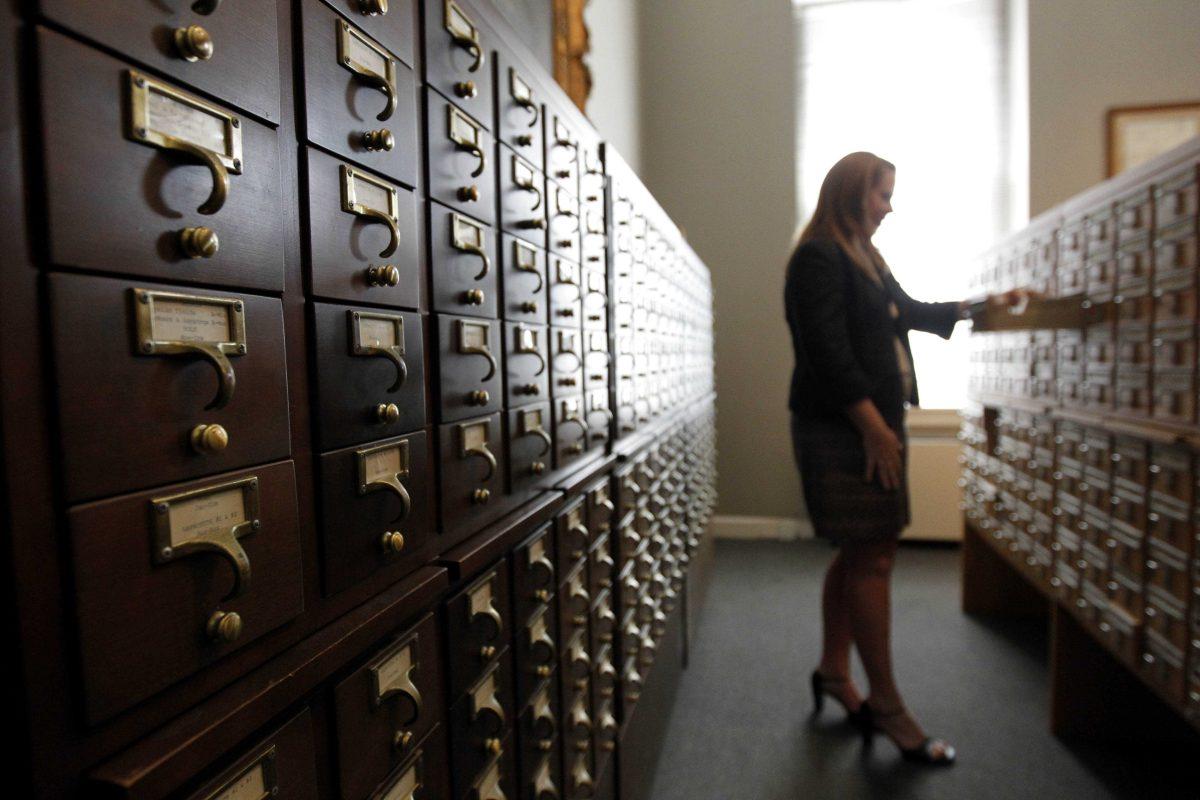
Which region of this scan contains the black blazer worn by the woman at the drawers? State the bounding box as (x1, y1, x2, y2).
(784, 241, 958, 426)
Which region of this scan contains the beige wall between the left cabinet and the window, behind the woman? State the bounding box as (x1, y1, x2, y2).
(640, 0, 800, 517)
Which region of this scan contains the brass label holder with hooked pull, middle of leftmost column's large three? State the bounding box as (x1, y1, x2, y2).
(132, 289, 246, 410)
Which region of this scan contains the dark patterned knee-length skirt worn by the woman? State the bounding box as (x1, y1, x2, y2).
(792, 414, 912, 546)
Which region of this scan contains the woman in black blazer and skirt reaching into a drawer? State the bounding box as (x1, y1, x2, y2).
(785, 152, 1018, 765)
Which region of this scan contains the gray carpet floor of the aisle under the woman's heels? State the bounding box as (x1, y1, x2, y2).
(649, 541, 1200, 800)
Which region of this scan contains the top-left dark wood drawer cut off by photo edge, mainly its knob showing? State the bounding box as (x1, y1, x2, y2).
(38, 0, 280, 123)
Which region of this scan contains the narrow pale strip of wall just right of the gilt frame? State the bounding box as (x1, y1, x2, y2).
(584, 0, 642, 172)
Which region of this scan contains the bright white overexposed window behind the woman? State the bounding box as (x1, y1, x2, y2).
(793, 0, 1015, 408)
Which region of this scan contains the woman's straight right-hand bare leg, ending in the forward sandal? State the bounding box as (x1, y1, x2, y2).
(842, 541, 925, 748)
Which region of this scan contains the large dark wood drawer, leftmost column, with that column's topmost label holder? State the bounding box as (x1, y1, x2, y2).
(38, 30, 283, 290)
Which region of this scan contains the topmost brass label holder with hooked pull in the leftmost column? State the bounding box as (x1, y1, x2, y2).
(126, 70, 242, 215)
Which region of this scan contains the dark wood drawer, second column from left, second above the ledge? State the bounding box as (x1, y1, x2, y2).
(312, 303, 426, 450)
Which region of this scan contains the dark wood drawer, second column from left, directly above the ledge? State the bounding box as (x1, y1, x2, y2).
(319, 431, 439, 594)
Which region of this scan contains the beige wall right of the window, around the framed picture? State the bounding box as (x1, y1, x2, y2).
(1028, 0, 1200, 216)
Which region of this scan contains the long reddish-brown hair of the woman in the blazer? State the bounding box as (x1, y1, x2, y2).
(798, 151, 896, 283)
